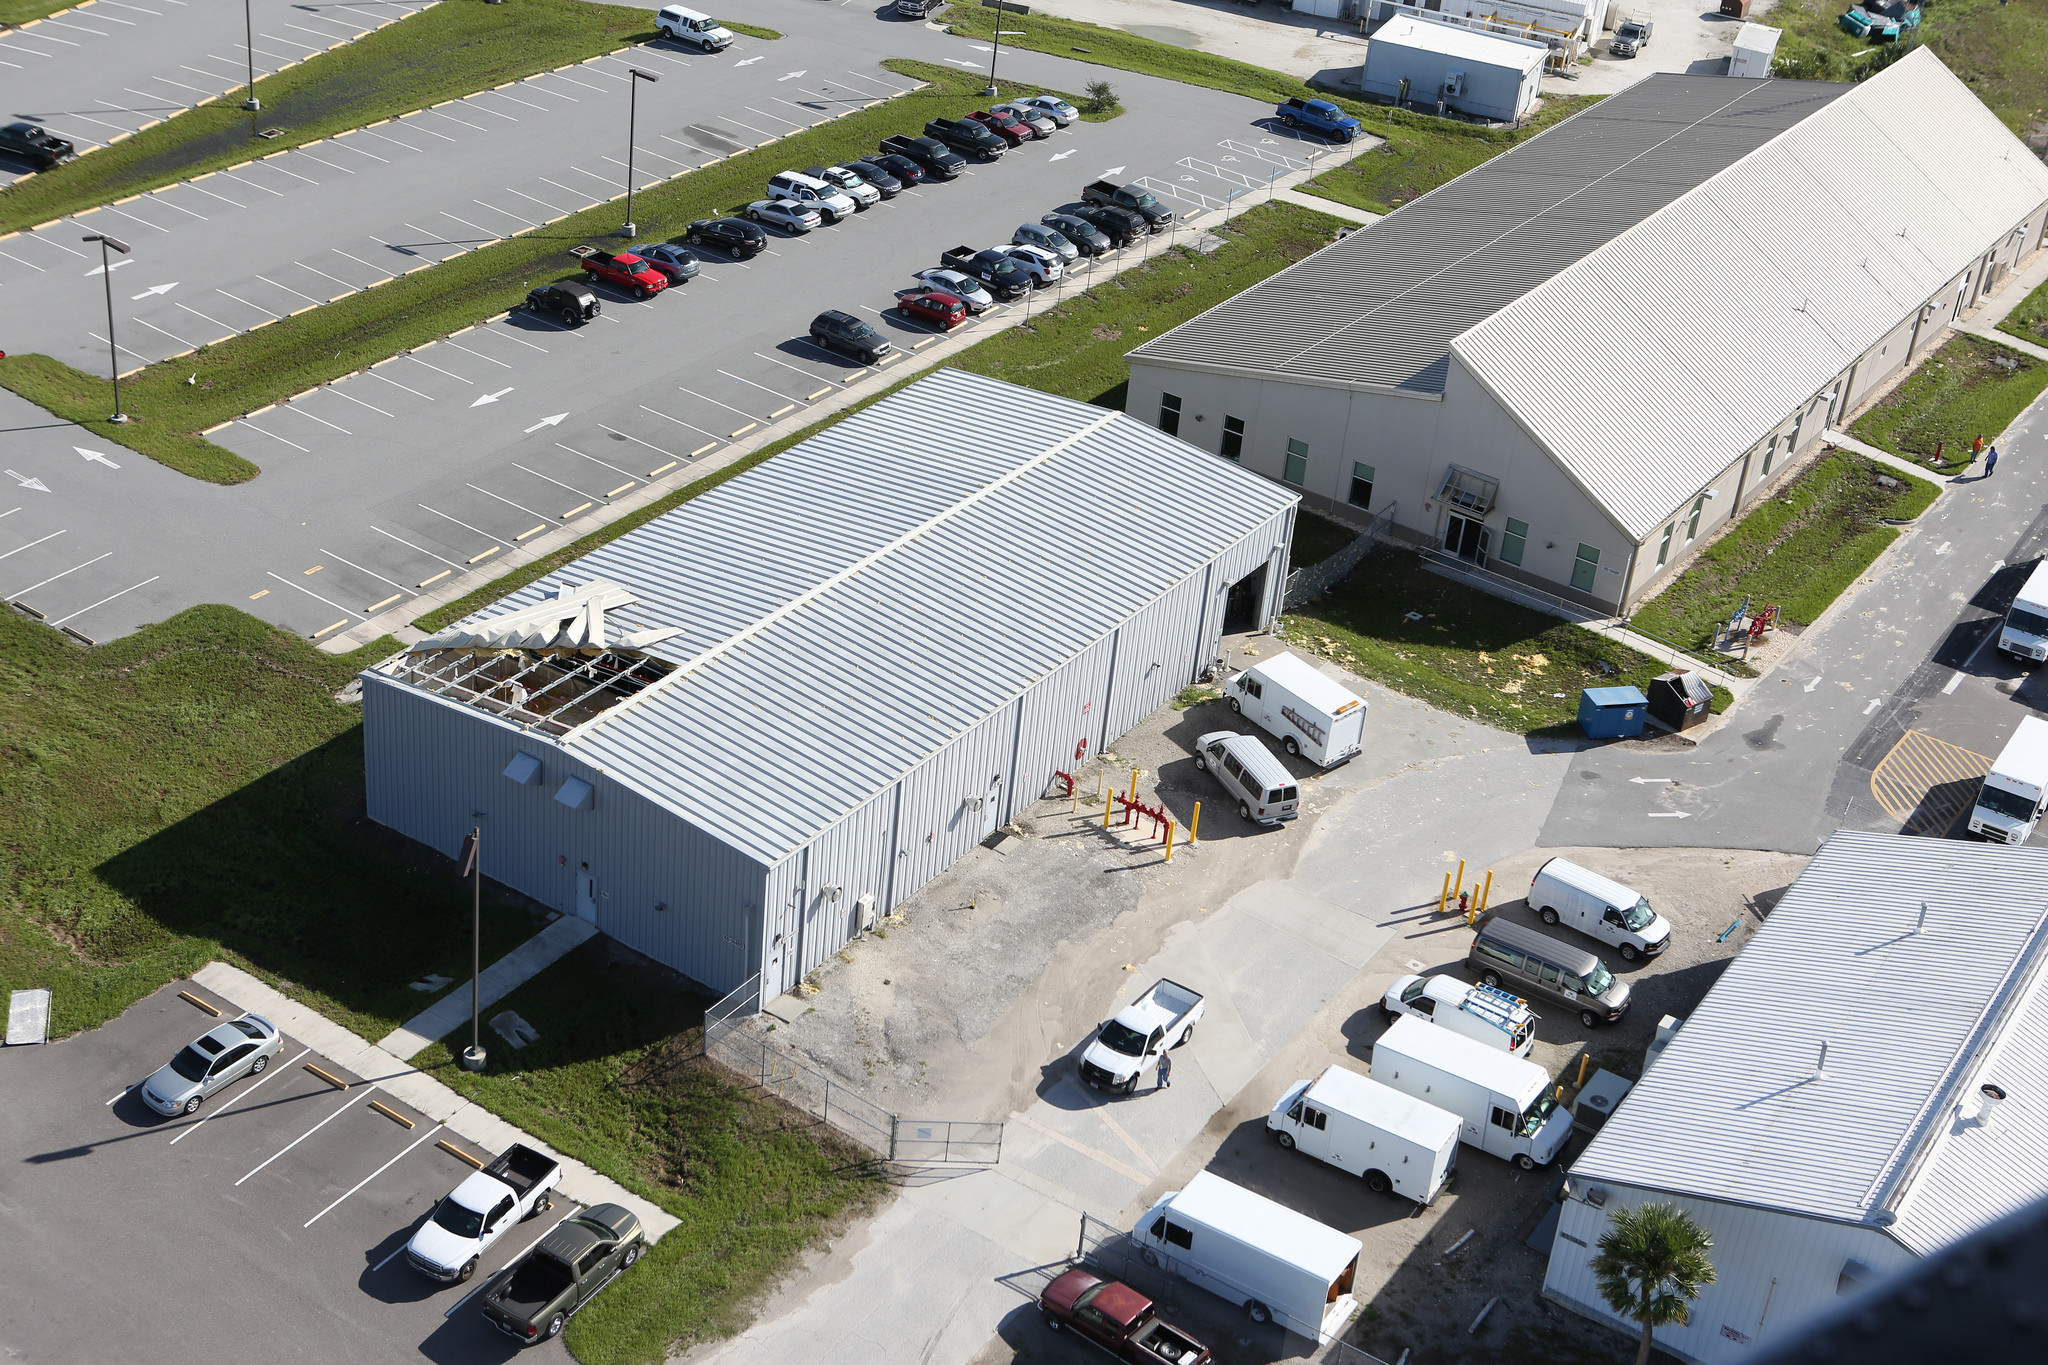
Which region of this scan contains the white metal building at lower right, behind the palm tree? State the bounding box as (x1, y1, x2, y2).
(1544, 831, 2048, 1365)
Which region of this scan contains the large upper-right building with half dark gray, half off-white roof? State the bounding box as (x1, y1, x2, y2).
(1126, 47, 2048, 612)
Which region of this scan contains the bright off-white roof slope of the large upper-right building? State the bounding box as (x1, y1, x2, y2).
(1458, 49, 2048, 540)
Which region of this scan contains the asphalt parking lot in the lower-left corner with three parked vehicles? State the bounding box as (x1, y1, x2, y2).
(0, 982, 573, 1365)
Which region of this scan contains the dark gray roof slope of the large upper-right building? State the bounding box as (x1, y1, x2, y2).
(1130, 76, 1851, 393)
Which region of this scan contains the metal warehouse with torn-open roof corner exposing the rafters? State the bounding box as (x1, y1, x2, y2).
(362, 370, 1298, 1001)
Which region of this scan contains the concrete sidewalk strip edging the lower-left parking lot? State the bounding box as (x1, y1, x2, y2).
(193, 961, 678, 1242)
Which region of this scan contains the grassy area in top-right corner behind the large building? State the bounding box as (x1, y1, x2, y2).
(1765, 0, 2048, 133)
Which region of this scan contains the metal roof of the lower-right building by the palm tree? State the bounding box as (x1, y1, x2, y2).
(1573, 831, 2048, 1250)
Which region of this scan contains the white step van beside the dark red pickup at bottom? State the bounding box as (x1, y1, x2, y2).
(1130, 1171, 1364, 1342)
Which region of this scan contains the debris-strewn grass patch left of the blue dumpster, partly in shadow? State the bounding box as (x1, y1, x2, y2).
(1280, 548, 1733, 735)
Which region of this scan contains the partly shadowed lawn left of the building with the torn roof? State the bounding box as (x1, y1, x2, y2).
(0, 606, 535, 1038)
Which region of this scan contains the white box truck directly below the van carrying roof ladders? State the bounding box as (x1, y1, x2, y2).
(1372, 1019, 1571, 1171)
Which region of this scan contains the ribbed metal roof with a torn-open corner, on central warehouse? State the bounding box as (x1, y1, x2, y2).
(395, 370, 1296, 862)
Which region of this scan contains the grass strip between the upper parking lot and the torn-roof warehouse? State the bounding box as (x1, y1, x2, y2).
(414, 203, 1350, 630)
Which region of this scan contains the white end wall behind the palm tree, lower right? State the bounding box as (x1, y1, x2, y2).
(1542, 1181, 1915, 1365)
